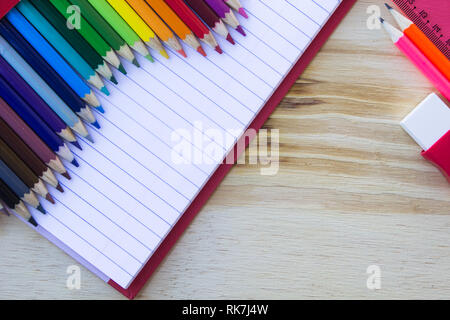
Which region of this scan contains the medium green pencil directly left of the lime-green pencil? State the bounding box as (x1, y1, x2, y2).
(70, 0, 139, 66)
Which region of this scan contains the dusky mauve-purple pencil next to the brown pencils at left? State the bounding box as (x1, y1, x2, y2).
(0, 97, 71, 180)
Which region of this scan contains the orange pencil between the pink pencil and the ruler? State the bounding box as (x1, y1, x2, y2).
(385, 3, 450, 81)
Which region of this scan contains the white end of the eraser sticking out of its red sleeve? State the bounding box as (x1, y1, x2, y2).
(401, 93, 450, 151)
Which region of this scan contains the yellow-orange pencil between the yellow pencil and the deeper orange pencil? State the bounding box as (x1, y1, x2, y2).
(127, 0, 187, 58)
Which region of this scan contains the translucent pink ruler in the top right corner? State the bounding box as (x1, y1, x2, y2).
(393, 0, 450, 59)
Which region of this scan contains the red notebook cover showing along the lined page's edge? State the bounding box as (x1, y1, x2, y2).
(0, 0, 356, 299)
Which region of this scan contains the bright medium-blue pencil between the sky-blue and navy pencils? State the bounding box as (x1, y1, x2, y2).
(5, 9, 104, 113)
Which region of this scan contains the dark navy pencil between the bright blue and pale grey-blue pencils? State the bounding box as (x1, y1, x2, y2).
(0, 20, 100, 128)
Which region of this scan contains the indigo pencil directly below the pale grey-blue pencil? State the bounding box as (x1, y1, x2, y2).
(0, 56, 77, 144)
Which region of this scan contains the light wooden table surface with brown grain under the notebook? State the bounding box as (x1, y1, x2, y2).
(0, 0, 450, 299)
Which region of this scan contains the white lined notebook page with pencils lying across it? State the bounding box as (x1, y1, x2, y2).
(29, 0, 340, 288)
